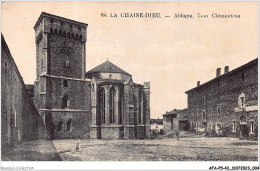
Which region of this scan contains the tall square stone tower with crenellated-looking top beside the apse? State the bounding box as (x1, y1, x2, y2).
(34, 12, 91, 139)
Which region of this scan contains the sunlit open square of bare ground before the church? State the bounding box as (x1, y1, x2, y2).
(53, 135, 258, 161)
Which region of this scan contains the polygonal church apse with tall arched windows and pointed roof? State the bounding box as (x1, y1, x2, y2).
(86, 61, 150, 139)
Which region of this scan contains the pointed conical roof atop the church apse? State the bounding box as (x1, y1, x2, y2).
(86, 60, 131, 76)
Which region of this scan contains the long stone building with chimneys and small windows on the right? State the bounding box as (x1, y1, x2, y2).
(186, 59, 258, 139)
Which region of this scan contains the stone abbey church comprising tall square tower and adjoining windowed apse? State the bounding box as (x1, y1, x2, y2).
(2, 12, 150, 146)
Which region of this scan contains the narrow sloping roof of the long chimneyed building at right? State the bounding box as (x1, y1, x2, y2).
(185, 58, 258, 94)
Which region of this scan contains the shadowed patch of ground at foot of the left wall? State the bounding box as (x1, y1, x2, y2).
(1, 140, 61, 161)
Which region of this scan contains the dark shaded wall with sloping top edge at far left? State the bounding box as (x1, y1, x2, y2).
(1, 35, 44, 148)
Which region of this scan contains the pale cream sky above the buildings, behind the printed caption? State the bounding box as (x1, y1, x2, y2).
(1, 1, 258, 118)
